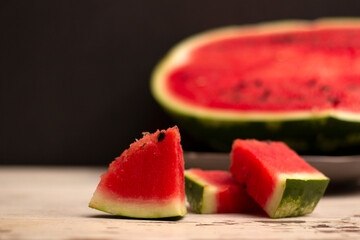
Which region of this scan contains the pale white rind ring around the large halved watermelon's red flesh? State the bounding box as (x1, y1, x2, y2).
(151, 18, 360, 122)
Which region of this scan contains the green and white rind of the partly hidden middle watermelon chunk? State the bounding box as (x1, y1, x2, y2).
(185, 171, 217, 213)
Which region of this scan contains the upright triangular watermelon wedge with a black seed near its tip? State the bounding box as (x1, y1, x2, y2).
(89, 127, 186, 218)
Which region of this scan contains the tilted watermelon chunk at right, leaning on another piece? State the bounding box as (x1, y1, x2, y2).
(230, 139, 329, 218)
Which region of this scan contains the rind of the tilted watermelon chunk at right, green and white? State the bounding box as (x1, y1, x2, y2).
(264, 174, 329, 218)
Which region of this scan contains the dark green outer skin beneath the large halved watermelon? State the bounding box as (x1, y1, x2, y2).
(170, 111, 360, 154)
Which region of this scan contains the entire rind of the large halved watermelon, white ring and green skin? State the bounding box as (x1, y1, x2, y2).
(150, 18, 360, 154)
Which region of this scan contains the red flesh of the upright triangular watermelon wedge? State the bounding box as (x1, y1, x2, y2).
(103, 131, 182, 199)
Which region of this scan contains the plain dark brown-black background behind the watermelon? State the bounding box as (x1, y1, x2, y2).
(0, 0, 360, 165)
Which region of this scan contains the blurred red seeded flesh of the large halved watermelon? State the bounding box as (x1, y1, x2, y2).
(167, 25, 360, 112)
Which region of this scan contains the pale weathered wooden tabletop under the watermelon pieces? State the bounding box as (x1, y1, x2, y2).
(0, 166, 360, 240)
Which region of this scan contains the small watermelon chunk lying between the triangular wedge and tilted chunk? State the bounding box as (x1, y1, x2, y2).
(185, 168, 261, 213)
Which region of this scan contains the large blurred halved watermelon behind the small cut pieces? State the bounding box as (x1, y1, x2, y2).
(151, 19, 360, 154)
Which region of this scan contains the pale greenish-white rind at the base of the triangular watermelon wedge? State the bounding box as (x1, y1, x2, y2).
(89, 190, 187, 218)
